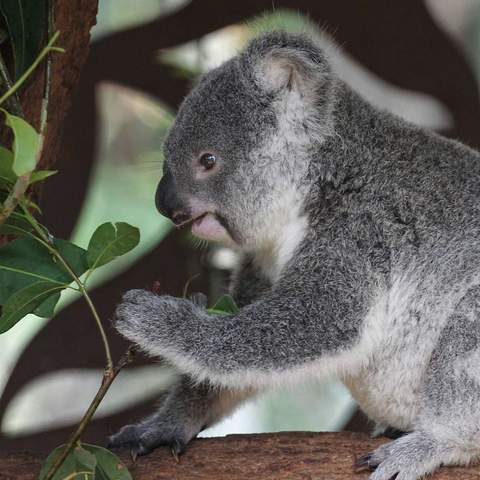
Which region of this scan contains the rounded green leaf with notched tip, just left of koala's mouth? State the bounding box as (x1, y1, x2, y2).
(87, 222, 140, 270)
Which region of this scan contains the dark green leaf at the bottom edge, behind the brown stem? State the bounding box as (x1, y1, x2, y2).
(38, 445, 97, 480)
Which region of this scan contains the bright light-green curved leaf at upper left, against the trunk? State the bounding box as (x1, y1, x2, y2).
(1, 108, 40, 176)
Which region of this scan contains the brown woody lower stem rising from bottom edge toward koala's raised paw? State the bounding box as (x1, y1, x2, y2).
(44, 347, 135, 480)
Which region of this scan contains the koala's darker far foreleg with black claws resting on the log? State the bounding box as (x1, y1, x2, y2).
(108, 377, 251, 456)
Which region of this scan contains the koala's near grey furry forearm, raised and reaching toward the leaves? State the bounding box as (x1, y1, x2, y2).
(117, 248, 368, 388)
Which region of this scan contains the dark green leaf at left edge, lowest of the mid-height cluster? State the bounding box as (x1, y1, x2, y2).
(0, 281, 64, 333)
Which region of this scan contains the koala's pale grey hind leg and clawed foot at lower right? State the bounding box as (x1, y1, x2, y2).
(362, 287, 480, 480)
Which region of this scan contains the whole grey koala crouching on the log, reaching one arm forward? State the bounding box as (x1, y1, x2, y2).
(110, 32, 480, 480)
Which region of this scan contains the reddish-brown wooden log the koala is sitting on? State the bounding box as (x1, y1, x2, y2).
(0, 432, 480, 480)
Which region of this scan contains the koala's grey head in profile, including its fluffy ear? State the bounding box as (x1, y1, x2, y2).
(156, 32, 335, 248)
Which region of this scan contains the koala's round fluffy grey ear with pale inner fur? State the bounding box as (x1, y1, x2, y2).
(243, 32, 331, 99)
